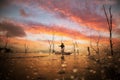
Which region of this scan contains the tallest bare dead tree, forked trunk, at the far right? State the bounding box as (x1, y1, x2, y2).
(103, 5, 113, 55)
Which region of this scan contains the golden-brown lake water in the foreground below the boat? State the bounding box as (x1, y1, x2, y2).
(0, 53, 119, 80)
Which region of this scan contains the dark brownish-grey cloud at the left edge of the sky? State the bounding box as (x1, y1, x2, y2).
(0, 21, 26, 37)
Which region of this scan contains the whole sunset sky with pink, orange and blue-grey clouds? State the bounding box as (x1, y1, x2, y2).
(0, 0, 120, 52)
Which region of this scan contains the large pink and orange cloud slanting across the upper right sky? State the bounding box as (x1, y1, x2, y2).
(35, 0, 116, 31)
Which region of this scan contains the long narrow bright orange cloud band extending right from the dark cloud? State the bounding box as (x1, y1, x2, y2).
(26, 25, 88, 39)
